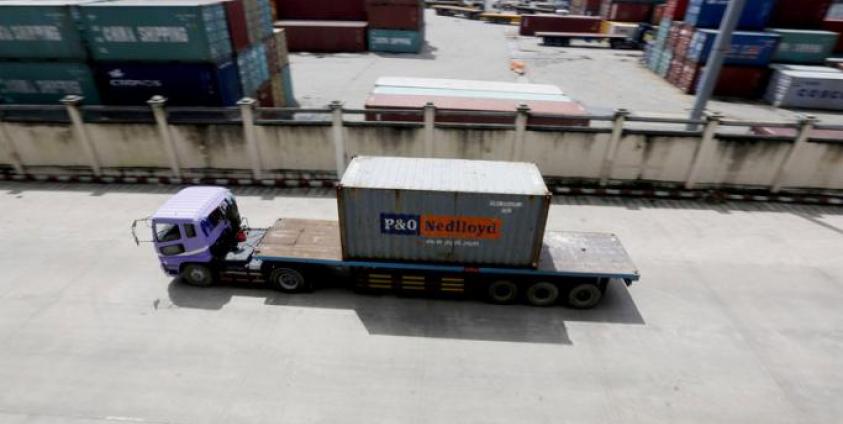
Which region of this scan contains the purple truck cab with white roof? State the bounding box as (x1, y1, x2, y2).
(145, 187, 241, 283)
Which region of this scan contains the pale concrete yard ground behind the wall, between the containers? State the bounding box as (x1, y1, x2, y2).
(290, 10, 843, 125)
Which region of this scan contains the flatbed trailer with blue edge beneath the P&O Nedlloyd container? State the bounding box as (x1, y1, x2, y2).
(218, 219, 639, 308)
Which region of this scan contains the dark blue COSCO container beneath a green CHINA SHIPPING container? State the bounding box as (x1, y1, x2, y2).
(97, 61, 242, 106)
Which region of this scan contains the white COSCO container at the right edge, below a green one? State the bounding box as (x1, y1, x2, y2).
(765, 70, 843, 110)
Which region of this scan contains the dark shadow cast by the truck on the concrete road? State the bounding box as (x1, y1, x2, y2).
(168, 279, 644, 345)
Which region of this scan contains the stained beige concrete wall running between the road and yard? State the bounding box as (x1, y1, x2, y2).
(0, 107, 843, 190)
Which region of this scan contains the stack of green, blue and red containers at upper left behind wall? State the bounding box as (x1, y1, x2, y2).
(0, 0, 292, 106)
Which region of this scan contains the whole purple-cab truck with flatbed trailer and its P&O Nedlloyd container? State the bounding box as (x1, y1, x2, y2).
(133, 157, 639, 308)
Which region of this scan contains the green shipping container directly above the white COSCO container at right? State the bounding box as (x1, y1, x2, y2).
(769, 29, 838, 64)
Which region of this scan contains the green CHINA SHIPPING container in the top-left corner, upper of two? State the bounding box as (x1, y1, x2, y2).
(0, 0, 94, 60)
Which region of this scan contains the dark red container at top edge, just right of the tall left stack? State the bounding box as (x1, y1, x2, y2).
(274, 0, 366, 21)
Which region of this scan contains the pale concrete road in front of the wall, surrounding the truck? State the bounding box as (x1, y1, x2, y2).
(0, 183, 843, 424)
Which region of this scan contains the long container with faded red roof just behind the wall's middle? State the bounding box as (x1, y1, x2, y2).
(366, 94, 589, 127)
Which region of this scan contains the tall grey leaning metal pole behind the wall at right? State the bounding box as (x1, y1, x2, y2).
(688, 0, 746, 131)
